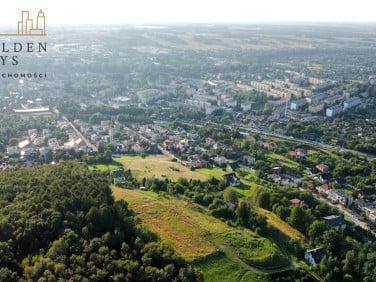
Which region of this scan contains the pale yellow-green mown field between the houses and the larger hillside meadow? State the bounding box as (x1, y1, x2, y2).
(114, 155, 208, 181)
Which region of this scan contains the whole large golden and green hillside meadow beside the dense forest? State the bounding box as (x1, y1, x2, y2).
(112, 186, 292, 276)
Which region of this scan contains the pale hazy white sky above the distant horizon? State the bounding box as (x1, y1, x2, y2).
(0, 0, 376, 27)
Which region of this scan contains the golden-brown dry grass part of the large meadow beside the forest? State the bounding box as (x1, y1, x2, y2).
(112, 186, 220, 260)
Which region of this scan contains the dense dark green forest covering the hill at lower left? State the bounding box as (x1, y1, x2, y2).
(0, 161, 202, 281)
